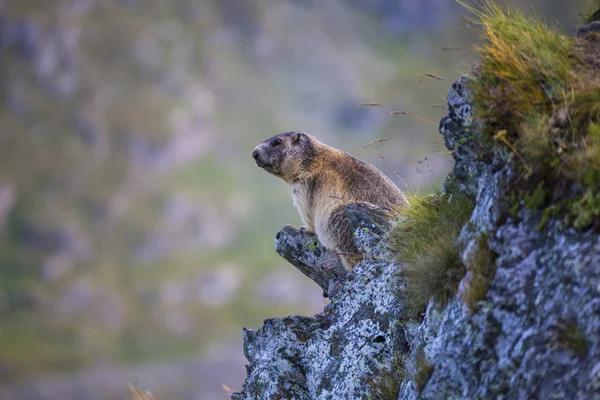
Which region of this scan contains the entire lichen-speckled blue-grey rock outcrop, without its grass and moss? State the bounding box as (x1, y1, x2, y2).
(232, 22, 600, 400)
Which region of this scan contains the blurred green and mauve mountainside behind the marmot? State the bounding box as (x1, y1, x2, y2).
(0, 0, 591, 400)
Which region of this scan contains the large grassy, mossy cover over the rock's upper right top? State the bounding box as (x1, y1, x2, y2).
(467, 0, 600, 229)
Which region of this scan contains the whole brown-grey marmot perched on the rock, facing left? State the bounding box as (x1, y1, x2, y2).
(252, 132, 406, 271)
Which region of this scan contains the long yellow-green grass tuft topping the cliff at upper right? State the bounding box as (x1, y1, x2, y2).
(465, 1, 574, 141)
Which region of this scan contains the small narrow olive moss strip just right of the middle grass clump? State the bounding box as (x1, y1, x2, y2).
(462, 235, 497, 312)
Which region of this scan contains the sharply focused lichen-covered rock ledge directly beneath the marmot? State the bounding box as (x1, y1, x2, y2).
(232, 205, 406, 400)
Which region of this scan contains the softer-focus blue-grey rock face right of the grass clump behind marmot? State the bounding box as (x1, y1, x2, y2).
(399, 78, 600, 399)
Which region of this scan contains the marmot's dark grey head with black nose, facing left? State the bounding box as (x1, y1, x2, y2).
(252, 132, 316, 182)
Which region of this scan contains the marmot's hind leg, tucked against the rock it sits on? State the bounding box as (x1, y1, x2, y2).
(327, 205, 362, 271)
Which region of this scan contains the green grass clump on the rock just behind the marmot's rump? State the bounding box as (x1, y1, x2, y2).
(391, 193, 474, 319)
